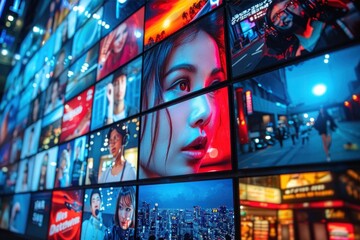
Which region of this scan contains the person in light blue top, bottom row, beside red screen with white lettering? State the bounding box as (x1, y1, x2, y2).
(81, 189, 106, 240)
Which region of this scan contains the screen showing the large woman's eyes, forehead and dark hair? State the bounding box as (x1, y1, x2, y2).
(142, 7, 227, 110)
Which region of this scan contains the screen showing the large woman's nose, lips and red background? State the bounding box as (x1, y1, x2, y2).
(139, 88, 231, 179)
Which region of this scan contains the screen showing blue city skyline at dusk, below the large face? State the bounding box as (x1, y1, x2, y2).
(137, 179, 235, 240)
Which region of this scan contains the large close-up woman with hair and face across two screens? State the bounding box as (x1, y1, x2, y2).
(139, 11, 227, 178)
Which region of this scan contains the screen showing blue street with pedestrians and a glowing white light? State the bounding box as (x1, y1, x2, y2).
(234, 46, 360, 169)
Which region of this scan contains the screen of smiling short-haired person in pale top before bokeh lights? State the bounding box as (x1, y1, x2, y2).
(85, 118, 140, 184)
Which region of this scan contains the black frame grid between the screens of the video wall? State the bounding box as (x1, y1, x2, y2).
(0, 0, 360, 239)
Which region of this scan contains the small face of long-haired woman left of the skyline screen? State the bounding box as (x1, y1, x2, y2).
(117, 195, 134, 230)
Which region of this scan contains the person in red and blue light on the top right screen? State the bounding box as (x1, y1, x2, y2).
(265, 0, 359, 62)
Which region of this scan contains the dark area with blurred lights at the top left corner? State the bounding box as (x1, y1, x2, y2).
(0, 0, 39, 101)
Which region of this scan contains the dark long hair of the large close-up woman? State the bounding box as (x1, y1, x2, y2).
(140, 11, 226, 167)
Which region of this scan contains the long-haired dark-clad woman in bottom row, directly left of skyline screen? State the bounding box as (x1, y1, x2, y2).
(104, 187, 135, 240)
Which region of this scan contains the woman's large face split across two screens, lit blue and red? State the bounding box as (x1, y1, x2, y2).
(140, 31, 225, 177)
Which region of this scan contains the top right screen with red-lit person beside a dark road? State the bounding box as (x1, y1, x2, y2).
(228, 0, 360, 78)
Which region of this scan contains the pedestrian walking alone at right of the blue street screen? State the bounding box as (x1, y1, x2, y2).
(314, 107, 337, 161)
